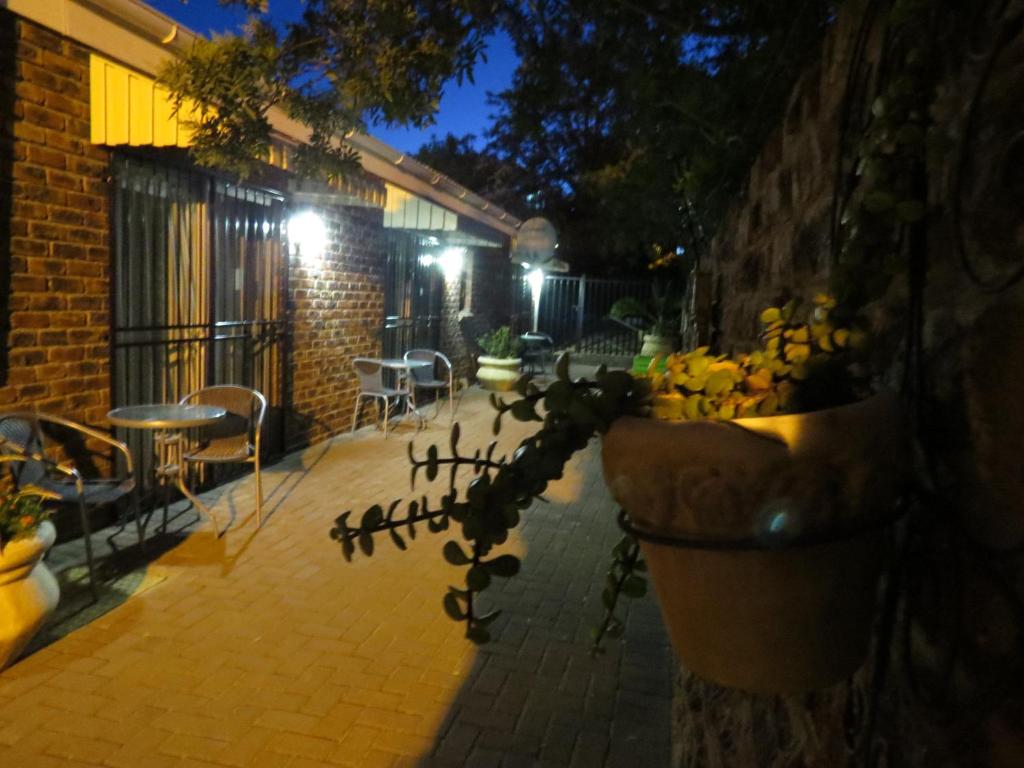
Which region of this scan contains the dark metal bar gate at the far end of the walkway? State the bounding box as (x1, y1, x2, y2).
(527, 274, 652, 356)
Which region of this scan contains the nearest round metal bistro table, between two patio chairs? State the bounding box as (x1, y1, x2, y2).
(106, 404, 227, 536)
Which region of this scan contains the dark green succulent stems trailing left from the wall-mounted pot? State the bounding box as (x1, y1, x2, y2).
(331, 355, 649, 643)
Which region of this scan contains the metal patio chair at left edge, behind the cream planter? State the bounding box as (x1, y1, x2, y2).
(0, 412, 143, 597)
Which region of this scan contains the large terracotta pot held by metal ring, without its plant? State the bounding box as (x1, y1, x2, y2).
(602, 395, 907, 693)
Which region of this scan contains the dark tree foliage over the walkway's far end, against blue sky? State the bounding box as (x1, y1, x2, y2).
(490, 0, 834, 270)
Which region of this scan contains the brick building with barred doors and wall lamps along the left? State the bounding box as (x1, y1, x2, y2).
(0, 0, 521, 460)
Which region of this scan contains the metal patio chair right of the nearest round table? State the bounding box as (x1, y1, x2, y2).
(178, 384, 266, 528)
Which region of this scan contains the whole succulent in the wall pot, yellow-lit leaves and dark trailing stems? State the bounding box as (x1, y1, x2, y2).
(331, 295, 863, 650)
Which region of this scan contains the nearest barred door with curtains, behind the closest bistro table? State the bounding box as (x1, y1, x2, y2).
(111, 157, 288, 477)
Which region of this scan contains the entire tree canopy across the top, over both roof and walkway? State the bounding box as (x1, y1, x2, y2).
(157, 0, 835, 271)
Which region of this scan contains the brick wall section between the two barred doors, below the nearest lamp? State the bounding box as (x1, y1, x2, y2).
(287, 208, 386, 449)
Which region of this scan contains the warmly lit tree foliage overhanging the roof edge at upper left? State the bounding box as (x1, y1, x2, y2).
(161, 0, 497, 175)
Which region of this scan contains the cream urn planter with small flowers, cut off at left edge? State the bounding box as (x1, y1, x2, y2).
(0, 456, 60, 670)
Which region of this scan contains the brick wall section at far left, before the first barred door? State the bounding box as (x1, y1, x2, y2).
(0, 11, 110, 424)
